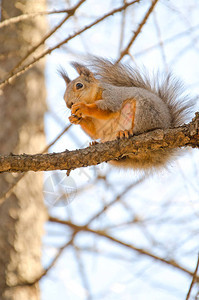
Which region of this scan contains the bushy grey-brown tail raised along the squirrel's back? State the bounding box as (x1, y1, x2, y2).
(89, 57, 194, 127)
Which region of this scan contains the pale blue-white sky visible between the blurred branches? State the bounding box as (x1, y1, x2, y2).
(40, 0, 199, 300)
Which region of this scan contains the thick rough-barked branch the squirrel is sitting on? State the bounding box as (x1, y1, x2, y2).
(0, 113, 199, 172)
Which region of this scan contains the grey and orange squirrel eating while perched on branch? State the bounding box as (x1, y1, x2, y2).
(60, 57, 193, 171)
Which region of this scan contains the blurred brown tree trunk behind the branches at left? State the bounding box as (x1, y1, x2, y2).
(0, 0, 46, 300)
